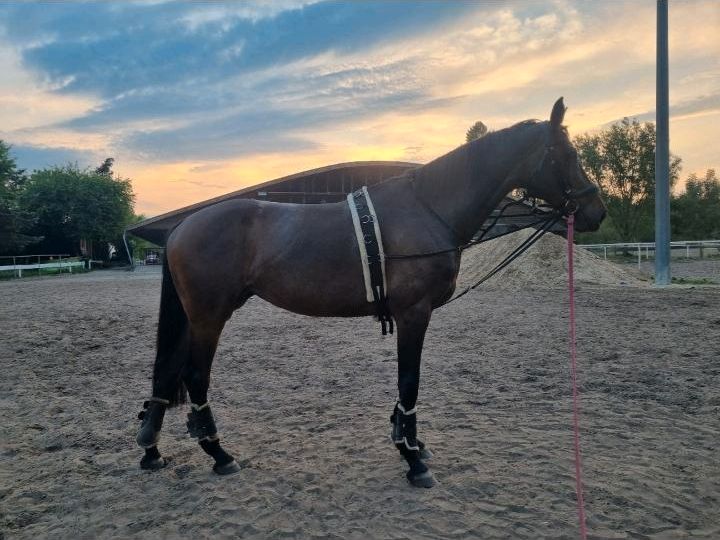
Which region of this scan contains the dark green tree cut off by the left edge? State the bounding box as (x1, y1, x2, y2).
(0, 140, 41, 254)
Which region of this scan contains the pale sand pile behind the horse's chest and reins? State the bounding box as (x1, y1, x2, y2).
(457, 229, 645, 291)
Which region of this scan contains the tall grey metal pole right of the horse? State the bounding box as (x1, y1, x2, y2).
(655, 0, 670, 286)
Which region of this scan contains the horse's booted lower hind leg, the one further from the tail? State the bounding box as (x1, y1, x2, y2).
(182, 323, 240, 475)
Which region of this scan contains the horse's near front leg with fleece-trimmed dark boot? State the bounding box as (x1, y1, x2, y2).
(390, 305, 435, 488)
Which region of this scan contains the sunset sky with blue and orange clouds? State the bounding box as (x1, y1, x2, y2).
(0, 0, 720, 216)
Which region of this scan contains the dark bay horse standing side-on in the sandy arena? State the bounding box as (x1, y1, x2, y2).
(137, 98, 605, 487)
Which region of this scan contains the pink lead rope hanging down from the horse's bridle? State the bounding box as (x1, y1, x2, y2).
(567, 214, 587, 540)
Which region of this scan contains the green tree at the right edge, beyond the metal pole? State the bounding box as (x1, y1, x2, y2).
(670, 169, 720, 240)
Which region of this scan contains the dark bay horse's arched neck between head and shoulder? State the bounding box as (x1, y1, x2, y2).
(415, 123, 546, 242)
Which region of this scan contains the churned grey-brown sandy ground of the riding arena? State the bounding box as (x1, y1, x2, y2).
(0, 266, 720, 539)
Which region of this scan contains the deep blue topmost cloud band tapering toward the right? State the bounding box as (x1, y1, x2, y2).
(4, 1, 473, 98)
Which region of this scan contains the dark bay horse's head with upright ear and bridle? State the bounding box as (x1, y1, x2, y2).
(523, 98, 607, 232)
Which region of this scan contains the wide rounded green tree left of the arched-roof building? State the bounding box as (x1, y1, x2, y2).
(20, 161, 135, 255)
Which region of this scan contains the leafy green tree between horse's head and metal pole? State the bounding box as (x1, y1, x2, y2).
(574, 118, 681, 242)
